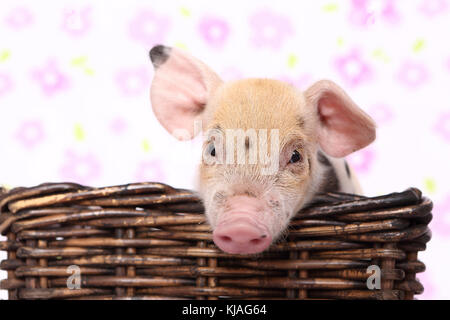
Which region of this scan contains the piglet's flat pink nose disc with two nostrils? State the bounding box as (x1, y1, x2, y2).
(213, 218, 272, 254)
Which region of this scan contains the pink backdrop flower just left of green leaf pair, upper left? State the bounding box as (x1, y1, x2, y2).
(32, 60, 69, 96)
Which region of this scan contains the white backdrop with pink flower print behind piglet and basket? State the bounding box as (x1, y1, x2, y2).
(0, 0, 450, 299)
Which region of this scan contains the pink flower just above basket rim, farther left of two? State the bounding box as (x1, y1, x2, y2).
(60, 150, 101, 184)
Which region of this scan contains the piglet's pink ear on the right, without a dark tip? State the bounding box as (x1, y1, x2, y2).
(305, 80, 376, 158)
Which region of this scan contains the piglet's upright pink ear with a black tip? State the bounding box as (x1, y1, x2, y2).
(150, 45, 222, 139)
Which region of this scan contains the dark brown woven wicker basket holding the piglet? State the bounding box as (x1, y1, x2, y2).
(0, 183, 432, 299)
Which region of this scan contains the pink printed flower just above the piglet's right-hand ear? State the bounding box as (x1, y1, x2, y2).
(334, 49, 372, 86)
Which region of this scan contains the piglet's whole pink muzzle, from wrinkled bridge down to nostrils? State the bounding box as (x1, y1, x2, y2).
(213, 196, 272, 254)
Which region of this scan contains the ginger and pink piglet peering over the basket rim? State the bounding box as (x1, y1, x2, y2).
(150, 45, 375, 254)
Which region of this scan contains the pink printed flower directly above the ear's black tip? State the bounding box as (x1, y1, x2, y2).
(129, 10, 170, 47)
